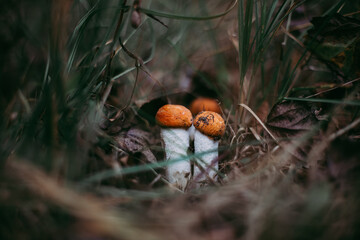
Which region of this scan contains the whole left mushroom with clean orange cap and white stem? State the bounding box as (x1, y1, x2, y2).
(155, 104, 192, 190)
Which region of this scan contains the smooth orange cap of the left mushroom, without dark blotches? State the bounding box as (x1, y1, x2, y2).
(155, 104, 192, 129)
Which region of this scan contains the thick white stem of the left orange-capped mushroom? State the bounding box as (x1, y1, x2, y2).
(161, 128, 191, 190)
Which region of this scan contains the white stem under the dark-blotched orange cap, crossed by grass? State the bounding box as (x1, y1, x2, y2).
(194, 130, 219, 182)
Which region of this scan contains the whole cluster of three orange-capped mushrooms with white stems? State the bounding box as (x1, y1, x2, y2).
(156, 98, 225, 189)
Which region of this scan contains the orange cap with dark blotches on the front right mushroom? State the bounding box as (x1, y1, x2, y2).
(193, 111, 225, 139)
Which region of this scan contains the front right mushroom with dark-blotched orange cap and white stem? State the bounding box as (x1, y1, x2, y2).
(193, 111, 225, 186)
